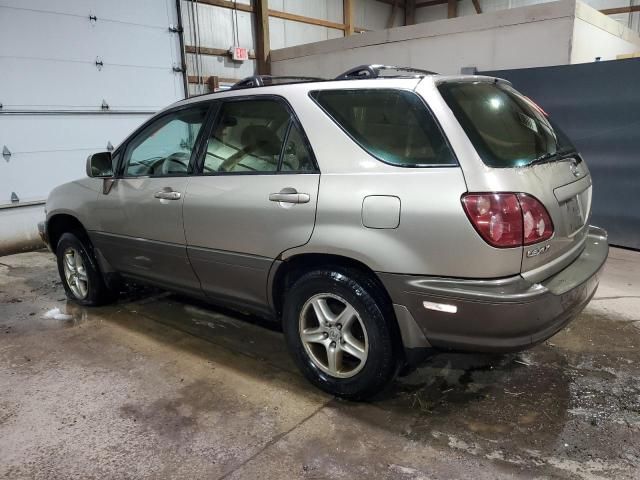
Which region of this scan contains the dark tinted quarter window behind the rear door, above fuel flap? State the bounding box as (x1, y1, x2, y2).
(310, 89, 457, 167)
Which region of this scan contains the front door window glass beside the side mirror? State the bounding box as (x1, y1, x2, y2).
(124, 106, 208, 177)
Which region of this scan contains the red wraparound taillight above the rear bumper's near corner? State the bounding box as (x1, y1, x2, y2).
(462, 193, 553, 248)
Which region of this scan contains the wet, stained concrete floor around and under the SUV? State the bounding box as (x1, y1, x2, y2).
(0, 249, 640, 479)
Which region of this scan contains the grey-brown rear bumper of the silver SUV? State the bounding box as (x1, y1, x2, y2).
(379, 227, 609, 352)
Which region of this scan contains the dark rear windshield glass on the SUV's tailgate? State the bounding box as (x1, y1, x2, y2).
(438, 82, 575, 168)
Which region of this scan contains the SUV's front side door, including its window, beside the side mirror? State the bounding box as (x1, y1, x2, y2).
(92, 104, 209, 293)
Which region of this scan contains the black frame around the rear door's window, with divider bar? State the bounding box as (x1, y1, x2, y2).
(191, 94, 320, 177)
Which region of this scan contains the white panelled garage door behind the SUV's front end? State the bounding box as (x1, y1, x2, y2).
(0, 0, 184, 206)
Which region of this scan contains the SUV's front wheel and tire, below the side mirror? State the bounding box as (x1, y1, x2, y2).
(56, 232, 116, 306)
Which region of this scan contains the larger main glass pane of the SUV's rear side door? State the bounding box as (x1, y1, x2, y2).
(203, 99, 290, 173)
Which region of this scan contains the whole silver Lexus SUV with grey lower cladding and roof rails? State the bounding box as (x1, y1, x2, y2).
(40, 65, 608, 399)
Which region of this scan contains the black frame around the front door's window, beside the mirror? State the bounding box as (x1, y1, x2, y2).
(113, 100, 217, 179)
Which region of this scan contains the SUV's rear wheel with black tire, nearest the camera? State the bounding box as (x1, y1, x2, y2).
(283, 268, 399, 400)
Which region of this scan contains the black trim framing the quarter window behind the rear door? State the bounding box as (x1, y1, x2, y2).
(307, 87, 460, 168)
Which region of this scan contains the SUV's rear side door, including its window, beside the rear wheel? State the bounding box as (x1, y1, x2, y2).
(184, 95, 320, 310)
